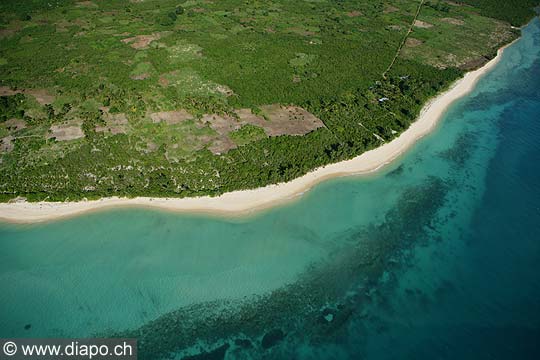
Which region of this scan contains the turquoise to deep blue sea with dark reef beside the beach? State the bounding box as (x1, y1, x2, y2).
(0, 19, 540, 359)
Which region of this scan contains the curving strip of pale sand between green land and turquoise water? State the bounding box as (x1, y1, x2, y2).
(0, 43, 517, 223)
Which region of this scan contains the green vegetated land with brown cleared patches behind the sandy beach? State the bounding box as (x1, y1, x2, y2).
(0, 0, 532, 201)
